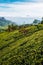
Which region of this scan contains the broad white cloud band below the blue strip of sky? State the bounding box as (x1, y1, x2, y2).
(0, 3, 43, 17)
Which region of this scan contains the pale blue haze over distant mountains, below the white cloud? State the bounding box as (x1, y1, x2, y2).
(6, 17, 41, 25)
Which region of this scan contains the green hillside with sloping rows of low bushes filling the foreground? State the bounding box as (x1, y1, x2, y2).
(0, 24, 43, 65)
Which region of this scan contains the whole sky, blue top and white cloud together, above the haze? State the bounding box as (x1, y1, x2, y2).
(0, 0, 43, 18)
